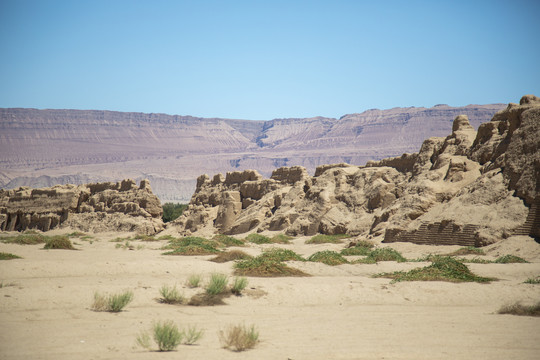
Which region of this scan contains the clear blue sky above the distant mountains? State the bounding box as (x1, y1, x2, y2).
(0, 0, 540, 120)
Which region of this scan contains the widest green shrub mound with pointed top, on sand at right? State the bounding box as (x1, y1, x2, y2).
(374, 256, 495, 283)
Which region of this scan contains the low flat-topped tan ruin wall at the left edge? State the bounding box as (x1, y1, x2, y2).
(0, 179, 163, 234)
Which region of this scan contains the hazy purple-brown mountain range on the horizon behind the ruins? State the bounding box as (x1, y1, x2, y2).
(0, 104, 506, 202)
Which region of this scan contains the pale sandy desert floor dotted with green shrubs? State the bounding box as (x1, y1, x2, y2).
(0, 230, 540, 359)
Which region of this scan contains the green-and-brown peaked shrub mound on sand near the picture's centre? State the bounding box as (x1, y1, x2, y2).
(234, 254, 309, 277)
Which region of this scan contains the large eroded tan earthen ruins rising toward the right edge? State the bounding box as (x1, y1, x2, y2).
(170, 95, 540, 246)
